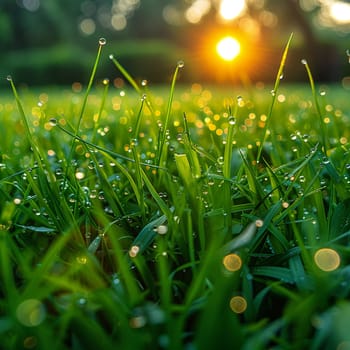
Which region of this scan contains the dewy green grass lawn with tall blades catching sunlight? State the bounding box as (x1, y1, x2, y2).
(0, 37, 350, 350)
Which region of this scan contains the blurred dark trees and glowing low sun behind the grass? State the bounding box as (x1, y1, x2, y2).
(0, 0, 350, 88)
